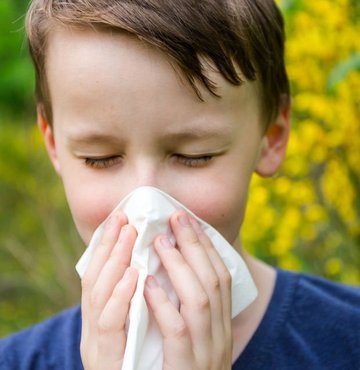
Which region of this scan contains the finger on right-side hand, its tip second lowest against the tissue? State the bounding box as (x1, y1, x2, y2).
(154, 236, 212, 361)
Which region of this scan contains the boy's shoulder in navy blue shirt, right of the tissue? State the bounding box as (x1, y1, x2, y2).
(234, 270, 360, 370)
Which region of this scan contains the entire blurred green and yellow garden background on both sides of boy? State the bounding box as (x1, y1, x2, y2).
(0, 0, 360, 337)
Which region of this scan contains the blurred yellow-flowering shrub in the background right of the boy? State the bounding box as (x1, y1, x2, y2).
(243, 0, 360, 284)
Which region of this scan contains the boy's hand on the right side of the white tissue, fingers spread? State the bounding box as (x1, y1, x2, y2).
(145, 211, 232, 370)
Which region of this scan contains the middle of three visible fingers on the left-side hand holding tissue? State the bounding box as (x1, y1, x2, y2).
(90, 225, 136, 317)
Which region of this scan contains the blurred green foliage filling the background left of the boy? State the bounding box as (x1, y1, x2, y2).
(0, 0, 84, 336)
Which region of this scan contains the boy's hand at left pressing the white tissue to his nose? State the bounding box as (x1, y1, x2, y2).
(80, 213, 138, 370)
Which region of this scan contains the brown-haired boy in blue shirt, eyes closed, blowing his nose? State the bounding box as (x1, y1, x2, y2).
(0, 0, 360, 370)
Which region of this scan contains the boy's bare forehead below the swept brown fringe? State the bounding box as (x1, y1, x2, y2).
(46, 27, 259, 132)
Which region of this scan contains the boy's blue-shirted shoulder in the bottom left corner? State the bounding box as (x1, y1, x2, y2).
(0, 306, 82, 370)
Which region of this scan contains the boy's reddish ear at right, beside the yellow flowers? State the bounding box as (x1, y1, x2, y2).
(255, 96, 291, 177)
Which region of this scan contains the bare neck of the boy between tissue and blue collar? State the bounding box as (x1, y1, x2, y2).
(232, 238, 276, 361)
